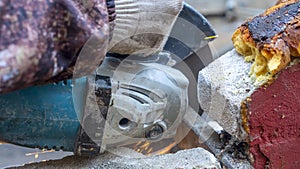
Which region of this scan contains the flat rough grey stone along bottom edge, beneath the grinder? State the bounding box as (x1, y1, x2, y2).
(16, 148, 220, 169)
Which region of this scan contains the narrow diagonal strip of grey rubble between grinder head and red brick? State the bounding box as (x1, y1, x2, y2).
(184, 107, 253, 169)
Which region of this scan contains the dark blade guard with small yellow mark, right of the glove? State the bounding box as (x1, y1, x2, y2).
(164, 3, 217, 60)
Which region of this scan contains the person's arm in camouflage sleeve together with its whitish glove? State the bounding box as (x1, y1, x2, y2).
(0, 0, 182, 93)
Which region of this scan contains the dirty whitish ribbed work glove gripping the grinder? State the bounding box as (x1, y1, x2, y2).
(109, 0, 183, 56)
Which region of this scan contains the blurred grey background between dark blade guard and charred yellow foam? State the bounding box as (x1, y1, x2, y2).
(185, 0, 277, 57)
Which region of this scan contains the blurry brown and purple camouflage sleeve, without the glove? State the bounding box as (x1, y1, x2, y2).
(0, 0, 112, 93)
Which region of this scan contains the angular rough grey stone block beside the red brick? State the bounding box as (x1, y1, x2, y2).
(198, 50, 255, 138)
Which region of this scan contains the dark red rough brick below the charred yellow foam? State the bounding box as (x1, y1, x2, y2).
(248, 64, 300, 169)
